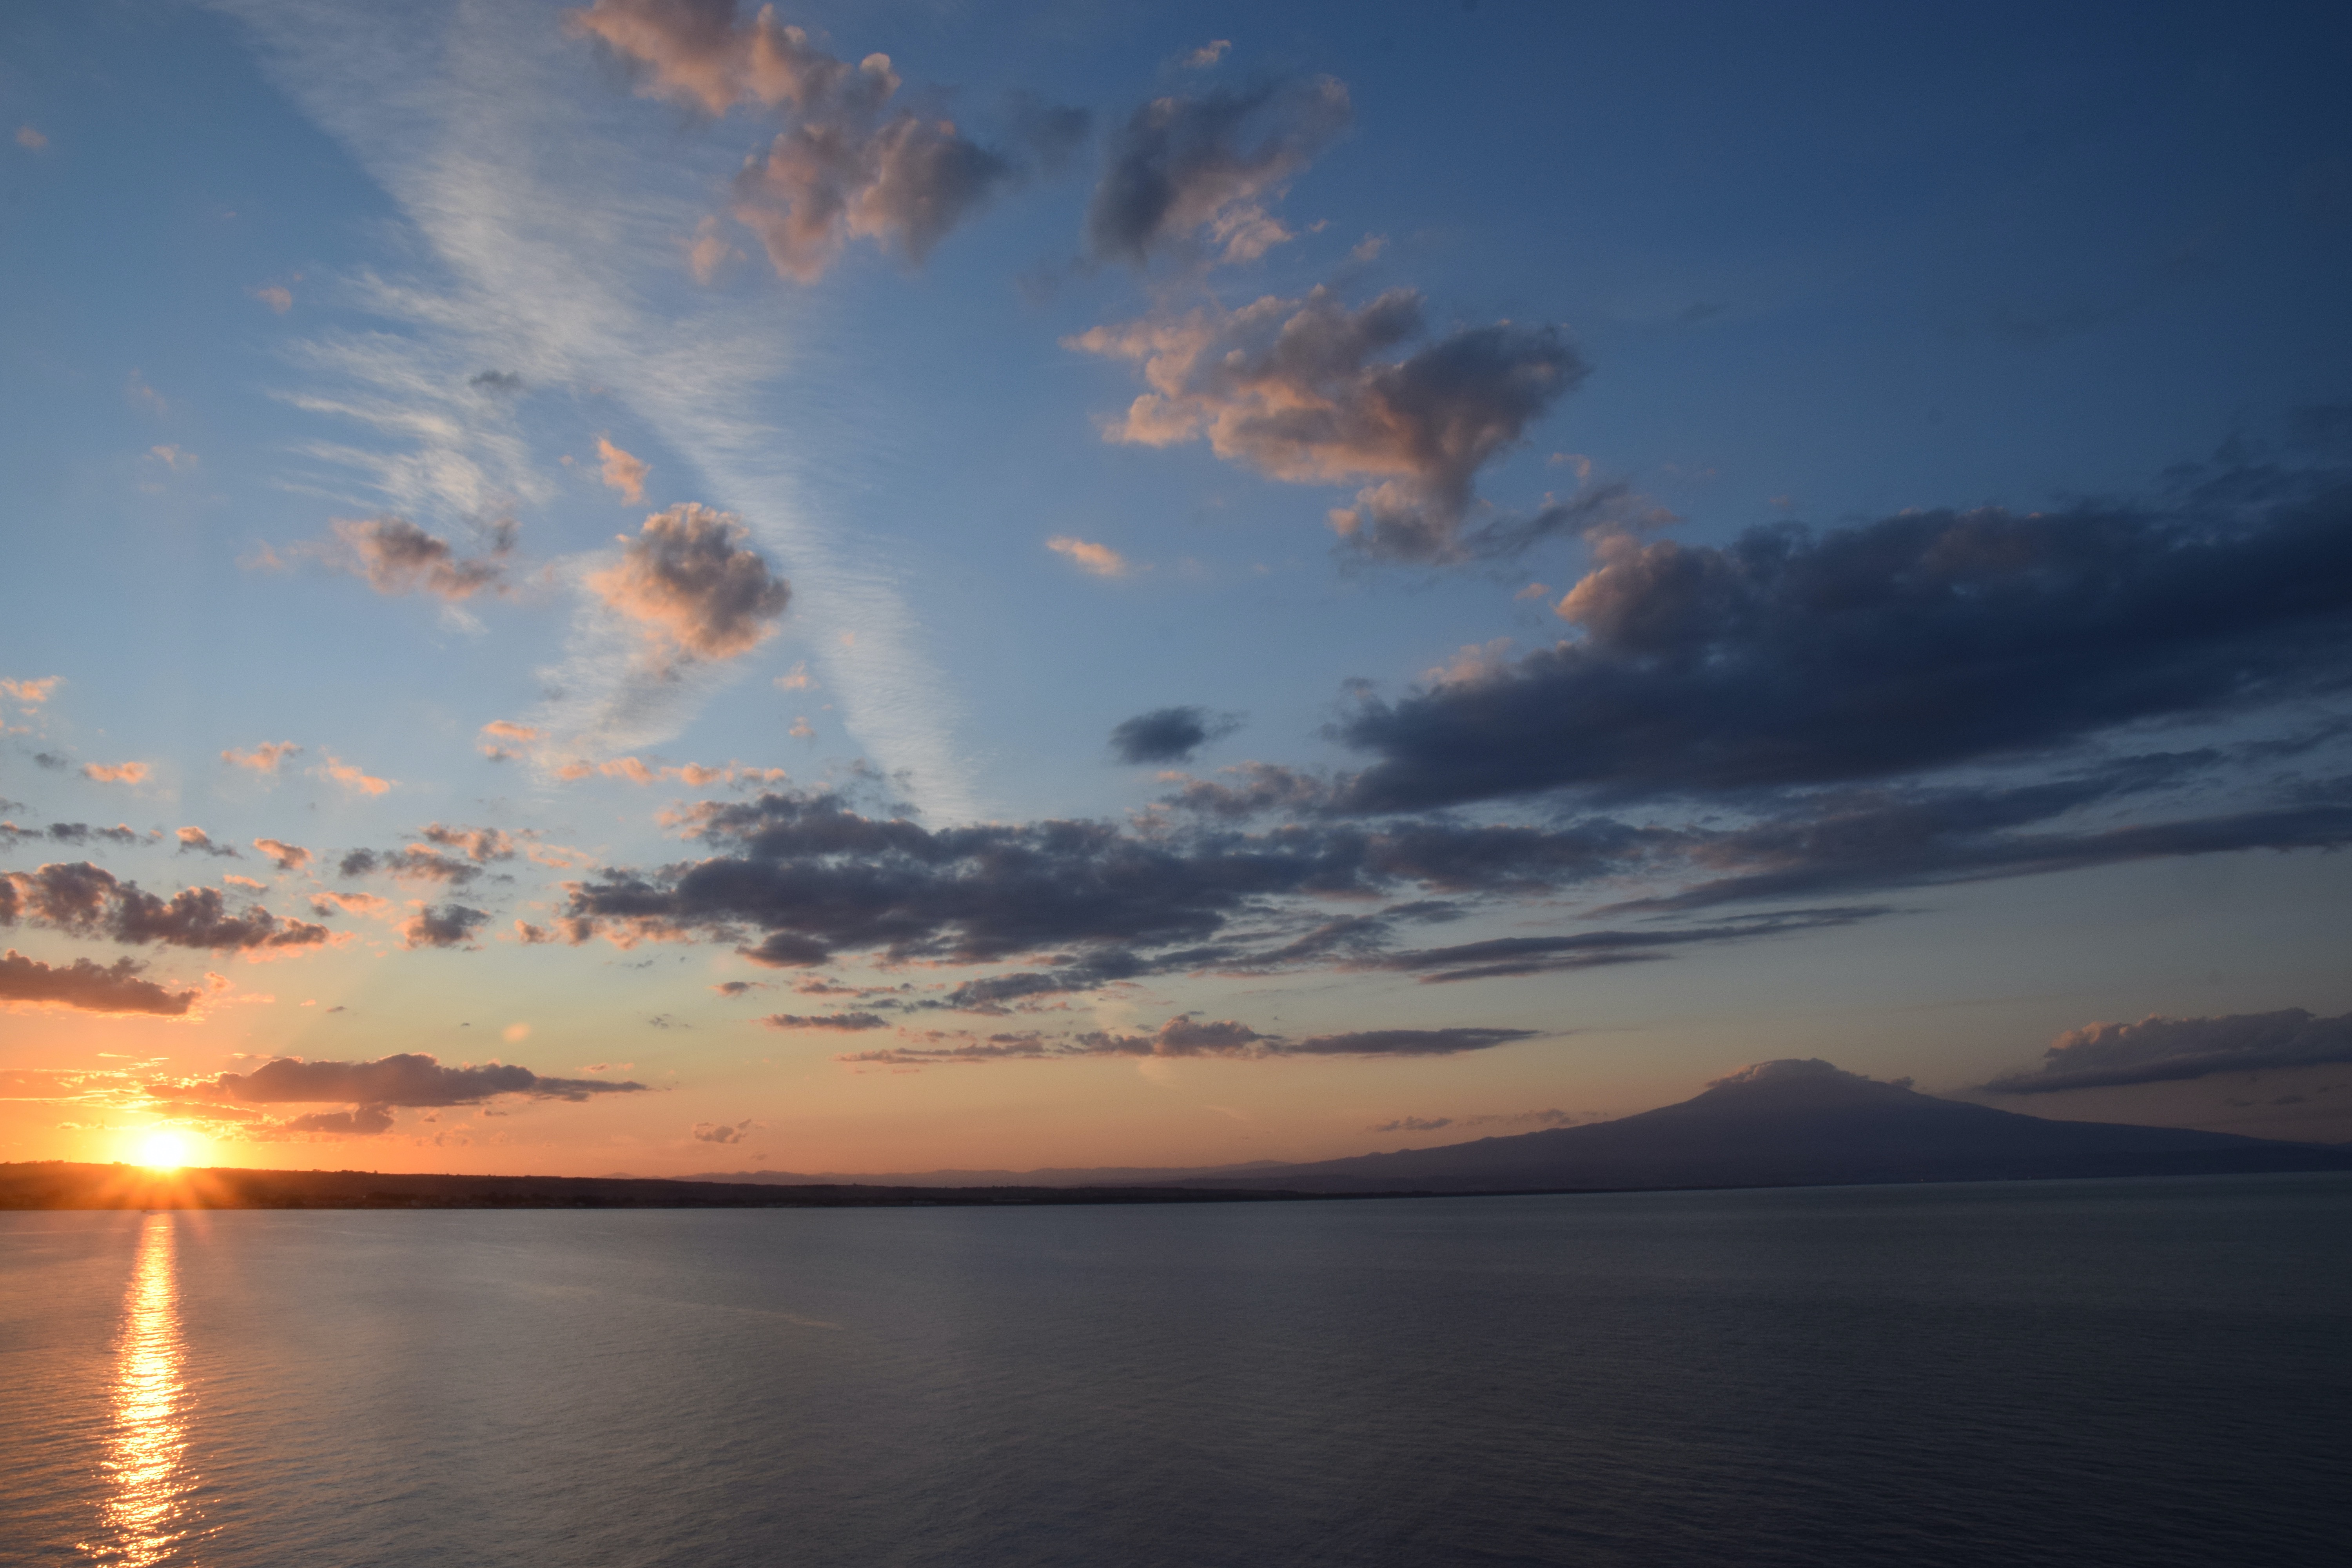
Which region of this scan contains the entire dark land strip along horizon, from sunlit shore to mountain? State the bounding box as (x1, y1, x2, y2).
(0, 1060, 2352, 1208)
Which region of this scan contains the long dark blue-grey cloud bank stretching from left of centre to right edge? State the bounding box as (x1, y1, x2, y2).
(541, 454, 2352, 1029)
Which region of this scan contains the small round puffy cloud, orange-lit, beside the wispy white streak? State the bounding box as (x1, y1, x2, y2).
(588, 501, 793, 661)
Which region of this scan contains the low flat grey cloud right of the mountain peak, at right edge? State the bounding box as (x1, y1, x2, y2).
(1985, 1006, 2352, 1096)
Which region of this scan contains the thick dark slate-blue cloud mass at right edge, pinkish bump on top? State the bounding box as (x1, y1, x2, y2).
(1336, 475, 2352, 811)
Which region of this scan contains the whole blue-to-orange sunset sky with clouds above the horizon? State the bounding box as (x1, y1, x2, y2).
(0, 0, 2352, 1176)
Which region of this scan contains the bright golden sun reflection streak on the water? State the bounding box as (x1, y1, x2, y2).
(82, 1213, 200, 1568)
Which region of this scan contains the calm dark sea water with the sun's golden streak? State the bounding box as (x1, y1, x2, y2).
(0, 1176, 2352, 1568)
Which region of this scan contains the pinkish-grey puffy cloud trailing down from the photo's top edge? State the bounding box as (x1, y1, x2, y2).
(569, 0, 1016, 282)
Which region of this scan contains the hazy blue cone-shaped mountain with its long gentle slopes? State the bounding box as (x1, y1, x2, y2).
(699, 1060, 2352, 1194)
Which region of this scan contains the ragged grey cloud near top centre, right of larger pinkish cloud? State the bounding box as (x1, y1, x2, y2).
(1087, 75, 1352, 266)
